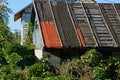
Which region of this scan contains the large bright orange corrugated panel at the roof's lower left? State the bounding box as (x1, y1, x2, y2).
(40, 21, 62, 48)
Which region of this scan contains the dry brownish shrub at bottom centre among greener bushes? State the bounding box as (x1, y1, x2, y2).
(60, 59, 93, 80)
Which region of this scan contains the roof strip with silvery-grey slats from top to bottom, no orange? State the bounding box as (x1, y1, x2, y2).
(83, 3, 115, 47)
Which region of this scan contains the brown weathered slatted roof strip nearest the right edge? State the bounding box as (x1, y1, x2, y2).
(100, 4, 120, 46)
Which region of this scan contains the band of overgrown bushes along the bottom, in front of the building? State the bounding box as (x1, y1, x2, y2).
(0, 45, 120, 80)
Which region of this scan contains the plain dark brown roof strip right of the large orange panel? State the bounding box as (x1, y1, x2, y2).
(51, 3, 80, 47)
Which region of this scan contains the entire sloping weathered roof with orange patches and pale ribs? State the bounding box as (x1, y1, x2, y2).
(34, 0, 120, 48)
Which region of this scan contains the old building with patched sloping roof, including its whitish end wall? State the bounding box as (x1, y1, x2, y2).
(14, 0, 120, 65)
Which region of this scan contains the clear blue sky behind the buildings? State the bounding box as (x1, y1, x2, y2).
(8, 0, 120, 32)
